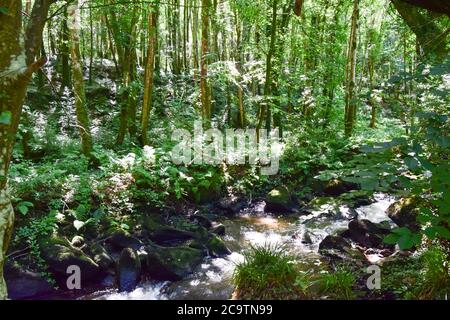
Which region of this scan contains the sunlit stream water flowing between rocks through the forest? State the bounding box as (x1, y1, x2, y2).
(82, 194, 393, 300)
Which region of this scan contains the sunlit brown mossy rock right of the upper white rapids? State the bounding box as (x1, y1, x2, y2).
(386, 198, 420, 231)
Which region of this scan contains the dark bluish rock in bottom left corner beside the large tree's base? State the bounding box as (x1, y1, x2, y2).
(4, 263, 54, 300)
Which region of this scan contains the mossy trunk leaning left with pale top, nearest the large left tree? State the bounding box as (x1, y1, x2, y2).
(67, 0, 92, 157)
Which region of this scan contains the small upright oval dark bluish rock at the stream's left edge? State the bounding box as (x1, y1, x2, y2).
(117, 248, 141, 292)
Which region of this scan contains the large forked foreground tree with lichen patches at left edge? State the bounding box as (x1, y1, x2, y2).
(0, 0, 55, 299)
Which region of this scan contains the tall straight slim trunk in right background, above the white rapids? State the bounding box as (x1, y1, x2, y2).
(345, 0, 359, 137)
